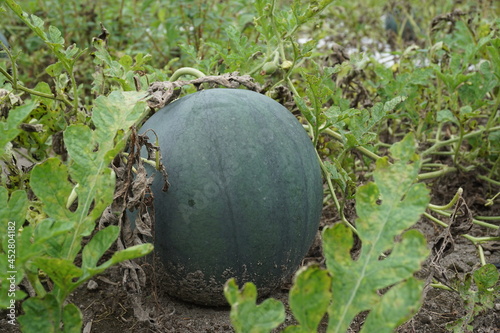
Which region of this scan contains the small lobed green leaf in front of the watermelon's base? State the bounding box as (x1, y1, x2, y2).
(224, 279, 285, 333)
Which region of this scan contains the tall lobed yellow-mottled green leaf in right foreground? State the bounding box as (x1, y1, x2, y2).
(323, 135, 429, 332)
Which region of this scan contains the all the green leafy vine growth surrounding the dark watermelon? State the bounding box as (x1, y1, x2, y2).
(0, 0, 500, 332)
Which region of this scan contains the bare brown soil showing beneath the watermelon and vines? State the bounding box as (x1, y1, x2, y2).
(0, 170, 500, 333)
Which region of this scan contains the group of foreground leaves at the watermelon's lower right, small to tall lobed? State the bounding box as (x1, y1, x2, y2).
(226, 134, 429, 332)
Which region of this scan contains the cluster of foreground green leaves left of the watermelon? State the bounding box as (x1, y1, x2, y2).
(1, 91, 152, 332)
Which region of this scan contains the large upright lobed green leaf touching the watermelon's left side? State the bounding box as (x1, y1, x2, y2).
(31, 92, 146, 259)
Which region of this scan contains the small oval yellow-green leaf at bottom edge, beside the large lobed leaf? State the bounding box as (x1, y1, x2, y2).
(289, 266, 332, 332)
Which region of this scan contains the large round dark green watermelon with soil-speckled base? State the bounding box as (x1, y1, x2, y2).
(141, 89, 323, 305)
